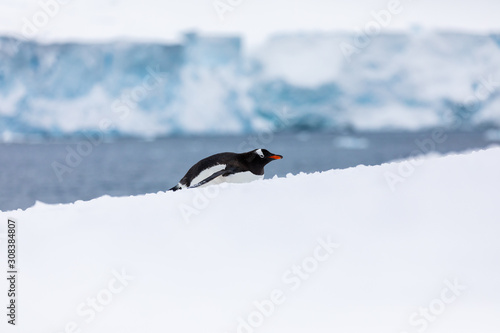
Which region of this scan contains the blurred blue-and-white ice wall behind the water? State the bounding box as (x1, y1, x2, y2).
(0, 31, 500, 138)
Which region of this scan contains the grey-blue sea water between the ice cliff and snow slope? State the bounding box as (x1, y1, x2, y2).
(0, 132, 494, 211)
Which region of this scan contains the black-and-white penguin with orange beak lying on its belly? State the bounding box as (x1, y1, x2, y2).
(169, 149, 283, 191)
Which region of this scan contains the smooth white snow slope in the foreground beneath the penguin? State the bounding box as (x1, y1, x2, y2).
(0, 148, 500, 333)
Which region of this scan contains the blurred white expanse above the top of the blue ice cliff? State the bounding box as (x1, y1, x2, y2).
(0, 0, 500, 43)
